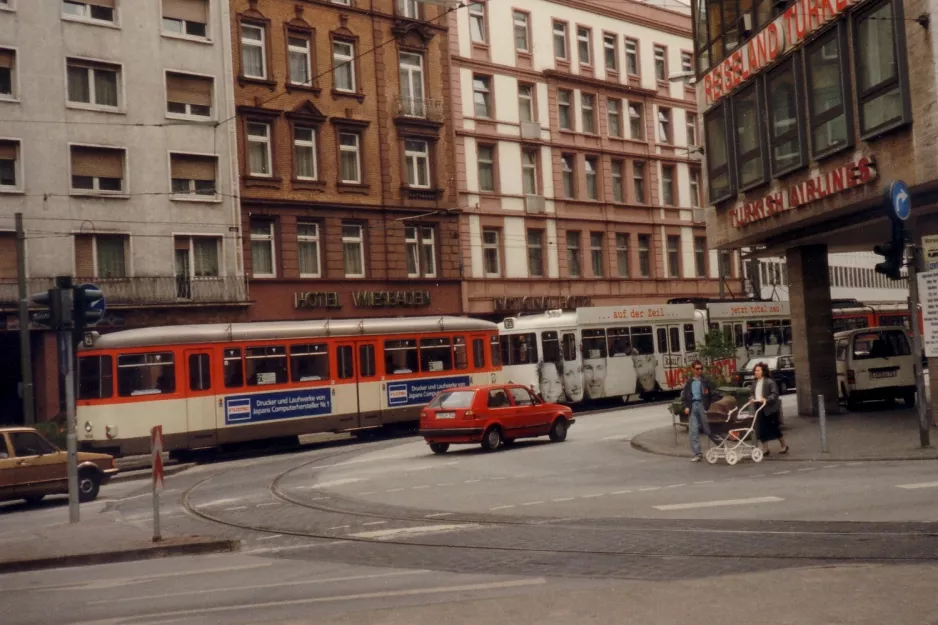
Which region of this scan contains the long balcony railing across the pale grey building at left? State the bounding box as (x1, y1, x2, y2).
(0, 276, 247, 307)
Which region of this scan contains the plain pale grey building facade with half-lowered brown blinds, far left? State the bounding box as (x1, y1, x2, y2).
(0, 0, 247, 420)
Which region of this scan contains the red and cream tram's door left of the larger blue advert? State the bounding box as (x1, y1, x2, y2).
(181, 349, 216, 449)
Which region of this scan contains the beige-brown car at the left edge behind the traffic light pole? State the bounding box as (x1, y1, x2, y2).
(0, 427, 118, 503)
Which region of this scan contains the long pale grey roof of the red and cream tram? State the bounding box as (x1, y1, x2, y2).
(84, 316, 497, 349)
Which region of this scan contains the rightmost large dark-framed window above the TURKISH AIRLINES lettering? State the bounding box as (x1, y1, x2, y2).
(853, 1, 911, 138)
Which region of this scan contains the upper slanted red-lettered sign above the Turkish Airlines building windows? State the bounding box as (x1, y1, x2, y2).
(703, 0, 864, 107)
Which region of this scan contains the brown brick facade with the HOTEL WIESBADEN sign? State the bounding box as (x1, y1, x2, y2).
(231, 0, 462, 320)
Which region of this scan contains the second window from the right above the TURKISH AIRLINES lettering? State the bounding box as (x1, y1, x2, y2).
(805, 25, 848, 157)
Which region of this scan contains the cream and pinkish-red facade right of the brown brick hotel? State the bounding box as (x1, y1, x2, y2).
(449, 0, 739, 318)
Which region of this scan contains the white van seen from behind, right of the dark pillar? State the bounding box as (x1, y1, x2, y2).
(834, 326, 918, 408)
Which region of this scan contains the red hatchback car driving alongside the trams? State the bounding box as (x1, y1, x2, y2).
(418, 384, 574, 454)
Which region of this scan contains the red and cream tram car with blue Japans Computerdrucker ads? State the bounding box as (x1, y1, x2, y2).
(77, 317, 502, 455)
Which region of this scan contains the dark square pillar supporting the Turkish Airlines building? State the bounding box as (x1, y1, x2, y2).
(786, 245, 839, 417)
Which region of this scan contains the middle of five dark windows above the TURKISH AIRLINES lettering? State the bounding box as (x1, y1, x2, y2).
(764, 59, 804, 177)
